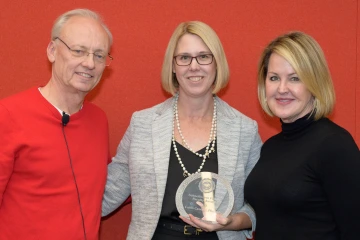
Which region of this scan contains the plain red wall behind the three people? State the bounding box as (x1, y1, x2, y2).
(0, 0, 360, 240)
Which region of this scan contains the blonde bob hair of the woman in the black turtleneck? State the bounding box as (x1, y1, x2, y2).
(257, 32, 335, 120)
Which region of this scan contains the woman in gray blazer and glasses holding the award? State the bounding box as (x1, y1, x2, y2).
(102, 21, 262, 240)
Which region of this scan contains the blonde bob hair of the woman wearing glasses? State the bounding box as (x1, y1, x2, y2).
(161, 21, 230, 95)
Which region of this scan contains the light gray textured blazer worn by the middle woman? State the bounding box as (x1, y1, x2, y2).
(102, 97, 262, 240)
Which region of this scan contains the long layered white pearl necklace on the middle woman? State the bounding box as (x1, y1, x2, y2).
(172, 94, 217, 177)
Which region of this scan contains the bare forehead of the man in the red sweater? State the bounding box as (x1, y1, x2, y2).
(60, 16, 110, 50)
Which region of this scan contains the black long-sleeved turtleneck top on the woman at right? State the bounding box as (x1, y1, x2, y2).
(244, 116, 360, 240)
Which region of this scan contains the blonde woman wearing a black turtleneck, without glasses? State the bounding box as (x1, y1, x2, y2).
(245, 32, 360, 240)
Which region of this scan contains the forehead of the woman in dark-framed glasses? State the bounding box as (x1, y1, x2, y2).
(175, 33, 211, 53)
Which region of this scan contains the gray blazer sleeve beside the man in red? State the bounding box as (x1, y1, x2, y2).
(102, 117, 134, 216)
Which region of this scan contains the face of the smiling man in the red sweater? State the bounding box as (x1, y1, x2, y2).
(48, 16, 110, 94)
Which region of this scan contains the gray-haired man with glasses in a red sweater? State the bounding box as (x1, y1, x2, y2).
(0, 9, 112, 240)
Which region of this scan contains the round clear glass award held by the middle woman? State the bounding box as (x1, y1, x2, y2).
(175, 172, 234, 223)
